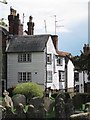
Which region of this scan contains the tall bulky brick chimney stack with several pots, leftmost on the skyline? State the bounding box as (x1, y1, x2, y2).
(8, 8, 23, 35)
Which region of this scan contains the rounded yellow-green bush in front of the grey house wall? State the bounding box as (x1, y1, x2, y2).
(13, 82, 43, 99)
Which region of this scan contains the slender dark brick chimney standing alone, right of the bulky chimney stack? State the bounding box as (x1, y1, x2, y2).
(27, 16, 35, 35)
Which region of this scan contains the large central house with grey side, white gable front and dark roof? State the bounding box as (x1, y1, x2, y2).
(7, 35, 74, 90)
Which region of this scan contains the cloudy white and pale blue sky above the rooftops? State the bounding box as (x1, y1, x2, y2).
(0, 0, 89, 55)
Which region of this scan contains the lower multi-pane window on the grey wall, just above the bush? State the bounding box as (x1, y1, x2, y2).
(18, 72, 32, 82)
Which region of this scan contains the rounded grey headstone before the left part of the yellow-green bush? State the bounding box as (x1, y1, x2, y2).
(12, 94, 26, 107)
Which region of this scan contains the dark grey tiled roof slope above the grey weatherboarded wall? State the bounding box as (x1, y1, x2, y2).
(7, 35, 50, 53)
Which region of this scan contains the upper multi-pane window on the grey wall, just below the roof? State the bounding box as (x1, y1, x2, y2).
(18, 53, 31, 62)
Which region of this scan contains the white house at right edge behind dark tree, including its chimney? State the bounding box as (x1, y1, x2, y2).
(74, 44, 90, 93)
